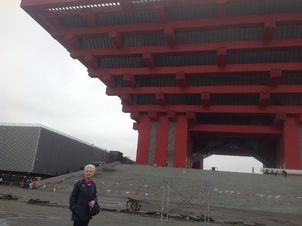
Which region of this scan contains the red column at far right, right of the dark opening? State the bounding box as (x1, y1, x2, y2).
(283, 117, 301, 170)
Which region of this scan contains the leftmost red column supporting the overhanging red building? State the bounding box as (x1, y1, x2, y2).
(136, 115, 150, 165)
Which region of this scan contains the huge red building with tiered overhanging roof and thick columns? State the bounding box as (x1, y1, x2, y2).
(21, 0, 302, 169)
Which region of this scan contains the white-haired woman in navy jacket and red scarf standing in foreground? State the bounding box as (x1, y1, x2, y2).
(69, 164, 97, 226)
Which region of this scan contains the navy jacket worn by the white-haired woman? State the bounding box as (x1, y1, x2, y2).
(69, 179, 98, 221)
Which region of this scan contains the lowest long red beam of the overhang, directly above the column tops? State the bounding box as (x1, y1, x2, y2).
(123, 105, 302, 115)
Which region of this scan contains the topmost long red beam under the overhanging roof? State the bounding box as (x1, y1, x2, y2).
(49, 12, 302, 37)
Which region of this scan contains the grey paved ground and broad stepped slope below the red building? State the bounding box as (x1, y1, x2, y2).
(0, 165, 302, 226)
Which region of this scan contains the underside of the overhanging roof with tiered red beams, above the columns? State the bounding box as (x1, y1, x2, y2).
(21, 0, 302, 125)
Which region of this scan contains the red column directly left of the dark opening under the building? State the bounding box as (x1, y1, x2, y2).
(173, 115, 188, 168)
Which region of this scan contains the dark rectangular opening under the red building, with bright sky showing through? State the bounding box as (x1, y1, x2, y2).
(191, 134, 280, 172)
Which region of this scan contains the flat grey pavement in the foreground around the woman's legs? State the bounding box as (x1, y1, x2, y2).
(0, 195, 198, 226)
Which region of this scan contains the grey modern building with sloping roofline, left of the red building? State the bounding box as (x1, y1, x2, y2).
(0, 123, 109, 176)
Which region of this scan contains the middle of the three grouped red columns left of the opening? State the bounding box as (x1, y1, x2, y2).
(154, 115, 169, 166)
